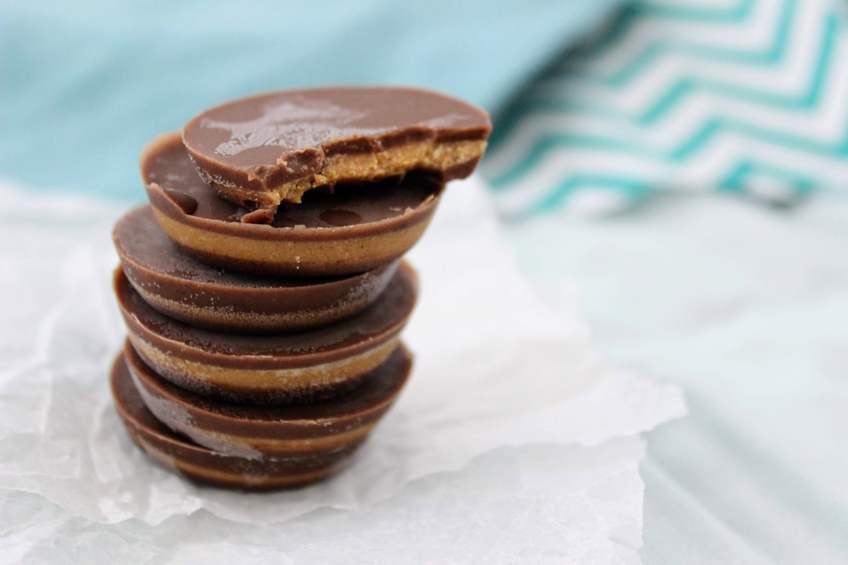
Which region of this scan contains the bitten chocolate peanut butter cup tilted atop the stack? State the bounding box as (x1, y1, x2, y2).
(182, 86, 492, 212)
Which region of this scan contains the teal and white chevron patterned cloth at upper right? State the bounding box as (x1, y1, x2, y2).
(484, 0, 848, 220)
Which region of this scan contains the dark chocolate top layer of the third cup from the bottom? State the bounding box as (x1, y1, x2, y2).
(115, 265, 417, 356)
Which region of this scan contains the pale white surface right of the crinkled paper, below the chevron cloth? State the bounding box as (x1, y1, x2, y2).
(510, 194, 848, 565)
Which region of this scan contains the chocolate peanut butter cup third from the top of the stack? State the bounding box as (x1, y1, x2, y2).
(112, 206, 398, 333)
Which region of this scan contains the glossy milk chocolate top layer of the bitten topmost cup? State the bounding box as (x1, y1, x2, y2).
(183, 86, 491, 170)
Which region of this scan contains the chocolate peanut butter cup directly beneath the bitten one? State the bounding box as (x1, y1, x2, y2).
(141, 134, 443, 276)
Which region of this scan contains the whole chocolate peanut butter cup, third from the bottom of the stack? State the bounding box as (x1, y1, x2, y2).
(115, 264, 418, 404)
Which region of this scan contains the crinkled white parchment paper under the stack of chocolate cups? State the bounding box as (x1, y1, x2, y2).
(0, 177, 684, 563)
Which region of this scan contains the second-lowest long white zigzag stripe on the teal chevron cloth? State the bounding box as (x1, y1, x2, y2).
(487, 1, 832, 177)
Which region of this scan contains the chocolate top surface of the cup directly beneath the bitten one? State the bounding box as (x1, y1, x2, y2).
(141, 134, 441, 227)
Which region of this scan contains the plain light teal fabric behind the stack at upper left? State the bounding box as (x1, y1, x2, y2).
(0, 0, 619, 199)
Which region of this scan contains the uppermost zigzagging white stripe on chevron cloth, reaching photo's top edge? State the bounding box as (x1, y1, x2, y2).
(561, 0, 780, 75)
